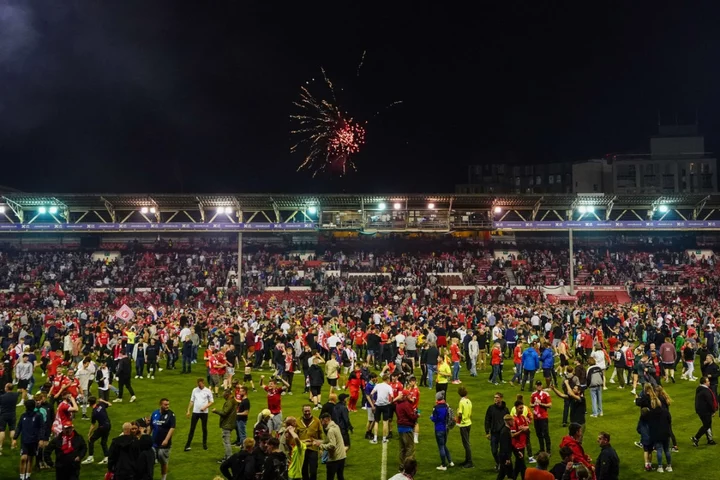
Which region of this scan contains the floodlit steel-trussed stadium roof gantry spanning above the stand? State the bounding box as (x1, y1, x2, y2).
(0, 192, 720, 233)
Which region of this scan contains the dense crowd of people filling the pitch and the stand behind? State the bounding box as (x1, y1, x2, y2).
(0, 237, 720, 480)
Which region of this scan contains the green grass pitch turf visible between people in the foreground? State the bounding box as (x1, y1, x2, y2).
(0, 357, 720, 480)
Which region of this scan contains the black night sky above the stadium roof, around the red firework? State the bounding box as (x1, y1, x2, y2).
(0, 0, 720, 193)
